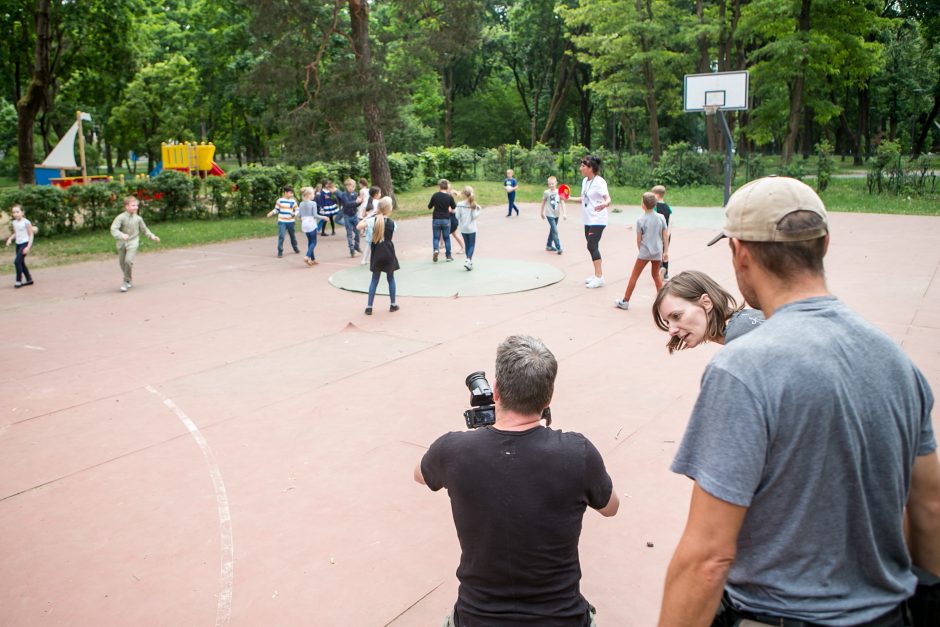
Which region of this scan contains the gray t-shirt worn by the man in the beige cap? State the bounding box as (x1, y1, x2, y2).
(672, 296, 936, 625)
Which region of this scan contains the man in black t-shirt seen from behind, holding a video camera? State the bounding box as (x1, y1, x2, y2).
(414, 335, 620, 627)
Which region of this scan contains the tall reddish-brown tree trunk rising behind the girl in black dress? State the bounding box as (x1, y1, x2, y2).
(349, 0, 395, 197)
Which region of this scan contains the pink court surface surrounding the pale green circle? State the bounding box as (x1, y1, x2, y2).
(0, 205, 940, 627)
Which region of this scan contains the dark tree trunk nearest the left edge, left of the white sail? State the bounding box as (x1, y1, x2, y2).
(16, 0, 52, 185)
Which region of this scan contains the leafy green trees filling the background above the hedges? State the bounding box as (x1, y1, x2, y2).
(0, 0, 940, 182)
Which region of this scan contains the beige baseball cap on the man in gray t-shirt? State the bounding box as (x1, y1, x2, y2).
(708, 176, 829, 246)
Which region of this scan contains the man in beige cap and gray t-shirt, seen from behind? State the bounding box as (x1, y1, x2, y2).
(659, 177, 940, 627)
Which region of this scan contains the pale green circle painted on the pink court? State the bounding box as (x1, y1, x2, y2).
(330, 255, 565, 297)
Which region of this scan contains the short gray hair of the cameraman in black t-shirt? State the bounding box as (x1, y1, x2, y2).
(496, 335, 558, 415)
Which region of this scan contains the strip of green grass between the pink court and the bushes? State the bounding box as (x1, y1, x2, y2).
(0, 179, 940, 273)
